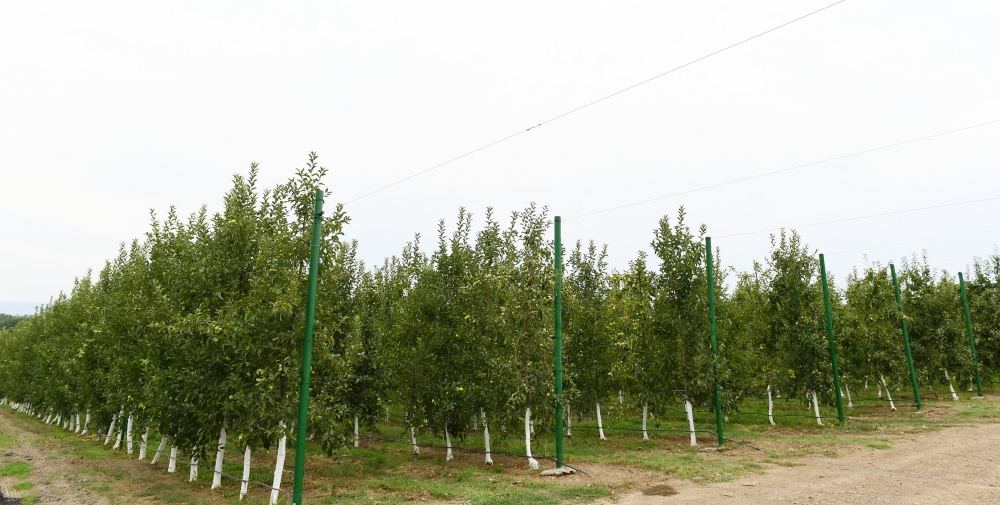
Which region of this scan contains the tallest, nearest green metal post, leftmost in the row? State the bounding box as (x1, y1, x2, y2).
(292, 189, 323, 505)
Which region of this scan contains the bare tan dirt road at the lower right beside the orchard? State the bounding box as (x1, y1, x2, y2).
(600, 424, 1000, 505)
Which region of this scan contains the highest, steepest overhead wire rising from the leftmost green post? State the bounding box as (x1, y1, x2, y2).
(346, 0, 847, 204)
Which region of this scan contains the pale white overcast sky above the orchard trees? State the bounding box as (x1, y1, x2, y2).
(0, 0, 1000, 312)
